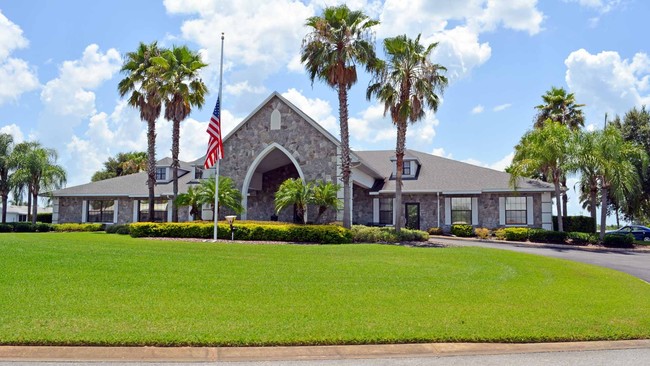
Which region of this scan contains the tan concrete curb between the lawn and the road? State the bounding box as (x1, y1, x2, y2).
(0, 339, 650, 362)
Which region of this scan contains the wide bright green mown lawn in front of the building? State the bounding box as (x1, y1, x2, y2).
(0, 233, 650, 345)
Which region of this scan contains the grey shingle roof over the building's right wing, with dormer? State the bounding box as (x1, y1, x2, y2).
(355, 150, 553, 193)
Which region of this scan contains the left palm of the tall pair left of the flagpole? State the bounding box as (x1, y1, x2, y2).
(117, 42, 164, 220)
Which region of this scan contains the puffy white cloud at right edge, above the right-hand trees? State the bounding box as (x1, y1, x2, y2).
(564, 49, 650, 118)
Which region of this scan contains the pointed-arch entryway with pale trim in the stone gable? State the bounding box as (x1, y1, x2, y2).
(242, 143, 305, 222)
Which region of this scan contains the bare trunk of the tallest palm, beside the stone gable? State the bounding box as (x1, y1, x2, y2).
(338, 84, 352, 229)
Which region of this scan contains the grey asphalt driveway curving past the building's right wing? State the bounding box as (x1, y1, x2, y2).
(430, 236, 650, 282)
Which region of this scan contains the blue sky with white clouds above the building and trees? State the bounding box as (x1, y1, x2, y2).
(0, 0, 650, 220)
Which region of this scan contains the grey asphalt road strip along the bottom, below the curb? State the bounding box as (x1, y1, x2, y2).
(0, 348, 650, 366)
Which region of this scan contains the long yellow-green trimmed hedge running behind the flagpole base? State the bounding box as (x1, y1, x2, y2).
(129, 221, 352, 244)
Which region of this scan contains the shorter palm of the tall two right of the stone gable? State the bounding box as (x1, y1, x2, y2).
(366, 35, 447, 232)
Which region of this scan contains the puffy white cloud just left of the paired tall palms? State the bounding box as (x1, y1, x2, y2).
(41, 44, 122, 118)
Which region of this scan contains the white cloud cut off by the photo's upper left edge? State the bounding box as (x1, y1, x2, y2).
(0, 12, 39, 105)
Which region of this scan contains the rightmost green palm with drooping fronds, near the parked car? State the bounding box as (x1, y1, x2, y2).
(593, 125, 648, 240)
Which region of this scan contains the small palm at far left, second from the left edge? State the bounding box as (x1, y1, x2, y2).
(14, 142, 66, 224)
